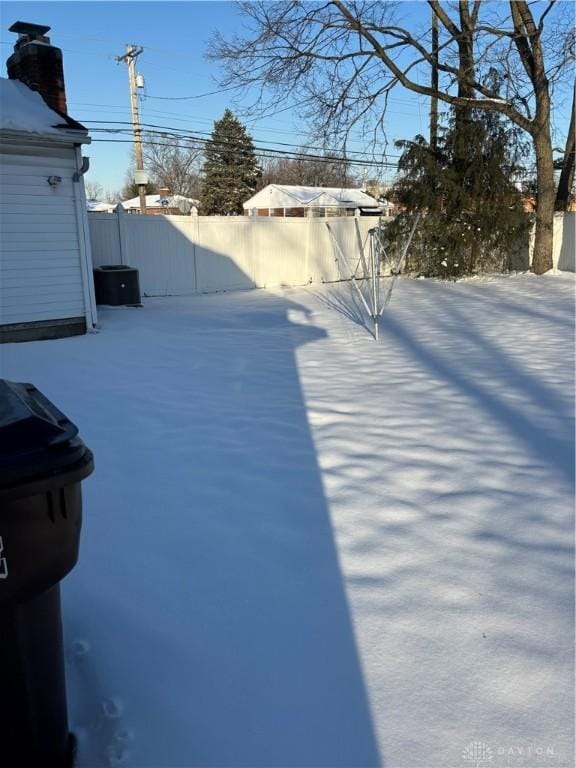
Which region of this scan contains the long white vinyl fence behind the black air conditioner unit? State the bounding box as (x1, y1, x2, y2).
(88, 213, 377, 296)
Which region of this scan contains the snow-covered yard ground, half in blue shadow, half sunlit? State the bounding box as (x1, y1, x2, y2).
(0, 275, 574, 768)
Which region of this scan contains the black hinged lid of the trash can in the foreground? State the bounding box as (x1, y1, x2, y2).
(0, 379, 89, 489)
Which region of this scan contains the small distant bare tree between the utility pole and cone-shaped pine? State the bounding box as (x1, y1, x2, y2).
(144, 135, 202, 199)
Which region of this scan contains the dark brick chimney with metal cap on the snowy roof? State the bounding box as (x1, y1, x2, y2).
(6, 21, 68, 114)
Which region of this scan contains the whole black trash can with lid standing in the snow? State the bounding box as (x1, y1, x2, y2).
(0, 379, 94, 768)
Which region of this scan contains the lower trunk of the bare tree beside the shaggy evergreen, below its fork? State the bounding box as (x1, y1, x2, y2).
(532, 126, 555, 275)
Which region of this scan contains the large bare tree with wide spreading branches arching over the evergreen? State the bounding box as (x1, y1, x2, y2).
(209, 0, 574, 273)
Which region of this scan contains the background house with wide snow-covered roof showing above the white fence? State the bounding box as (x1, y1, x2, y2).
(243, 184, 382, 216)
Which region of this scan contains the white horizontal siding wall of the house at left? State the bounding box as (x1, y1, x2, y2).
(0, 144, 87, 326)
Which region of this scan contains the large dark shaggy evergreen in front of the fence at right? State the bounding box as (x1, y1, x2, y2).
(387, 110, 529, 278)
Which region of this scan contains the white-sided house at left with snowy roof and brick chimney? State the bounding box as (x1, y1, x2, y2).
(0, 22, 96, 341)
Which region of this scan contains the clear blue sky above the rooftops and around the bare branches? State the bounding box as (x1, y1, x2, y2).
(0, 0, 572, 198)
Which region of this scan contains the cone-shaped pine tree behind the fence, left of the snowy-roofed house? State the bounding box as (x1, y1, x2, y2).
(200, 109, 262, 216)
